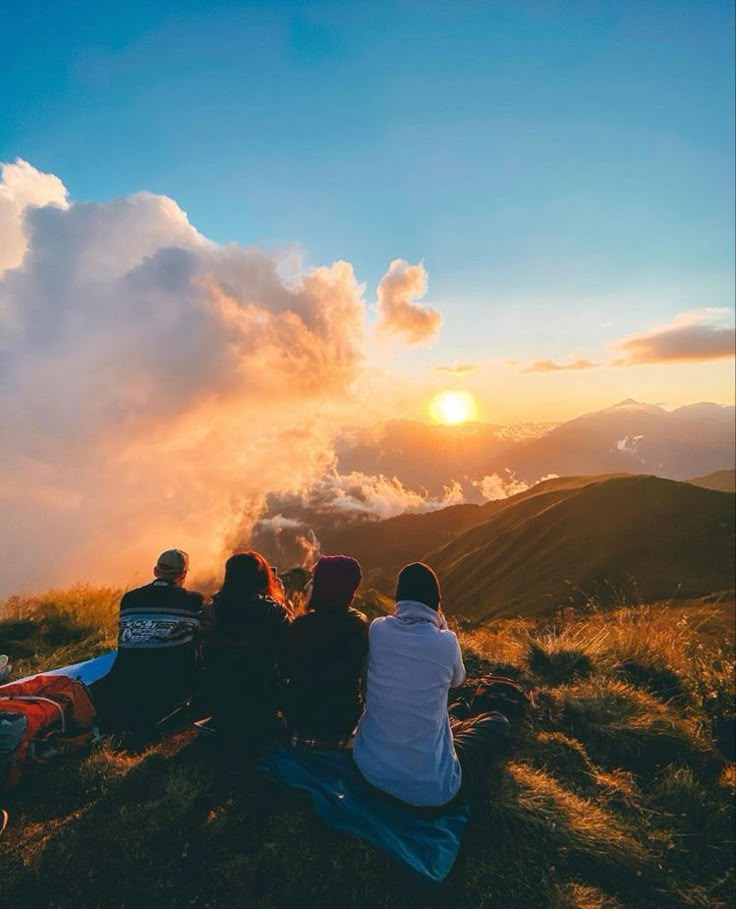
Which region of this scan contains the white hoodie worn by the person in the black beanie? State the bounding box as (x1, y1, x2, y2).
(353, 600, 465, 807)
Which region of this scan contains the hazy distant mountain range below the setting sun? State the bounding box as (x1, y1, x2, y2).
(337, 398, 736, 494)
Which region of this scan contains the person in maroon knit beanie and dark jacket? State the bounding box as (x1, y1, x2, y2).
(282, 555, 368, 749)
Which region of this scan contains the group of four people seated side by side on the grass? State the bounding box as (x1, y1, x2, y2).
(95, 549, 508, 809)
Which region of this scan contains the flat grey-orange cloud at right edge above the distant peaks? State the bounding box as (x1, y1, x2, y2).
(614, 308, 736, 366)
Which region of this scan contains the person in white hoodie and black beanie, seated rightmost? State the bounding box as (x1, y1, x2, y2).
(353, 562, 508, 808)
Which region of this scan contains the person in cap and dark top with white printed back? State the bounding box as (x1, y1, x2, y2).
(93, 549, 204, 744)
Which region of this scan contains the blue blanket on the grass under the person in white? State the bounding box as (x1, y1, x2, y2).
(259, 746, 470, 883)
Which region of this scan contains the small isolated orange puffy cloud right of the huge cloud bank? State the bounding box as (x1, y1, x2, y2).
(378, 259, 442, 344)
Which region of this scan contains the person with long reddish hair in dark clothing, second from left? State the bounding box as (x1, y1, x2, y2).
(202, 552, 290, 752)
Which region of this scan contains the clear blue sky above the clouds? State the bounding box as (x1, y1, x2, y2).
(0, 0, 734, 412)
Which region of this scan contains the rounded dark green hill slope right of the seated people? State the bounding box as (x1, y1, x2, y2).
(427, 476, 734, 620)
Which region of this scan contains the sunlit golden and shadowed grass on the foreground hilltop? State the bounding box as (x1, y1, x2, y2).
(0, 587, 736, 909)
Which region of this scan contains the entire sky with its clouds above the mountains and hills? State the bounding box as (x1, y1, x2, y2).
(0, 0, 735, 583)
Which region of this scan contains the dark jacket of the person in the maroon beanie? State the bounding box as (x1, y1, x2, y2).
(282, 609, 368, 741)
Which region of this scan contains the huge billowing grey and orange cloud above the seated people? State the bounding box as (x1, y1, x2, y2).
(0, 162, 423, 592)
